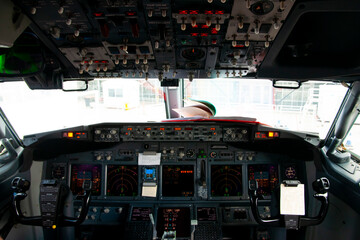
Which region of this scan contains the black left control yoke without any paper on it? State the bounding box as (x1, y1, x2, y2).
(11, 177, 92, 229)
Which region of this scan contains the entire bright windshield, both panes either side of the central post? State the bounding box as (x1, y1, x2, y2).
(0, 78, 347, 138)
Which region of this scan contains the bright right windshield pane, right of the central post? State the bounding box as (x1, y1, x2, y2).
(185, 78, 347, 138)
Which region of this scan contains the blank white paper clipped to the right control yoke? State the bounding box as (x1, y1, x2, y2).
(280, 184, 305, 216)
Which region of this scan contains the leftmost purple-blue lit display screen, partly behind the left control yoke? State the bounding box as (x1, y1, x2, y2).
(70, 164, 101, 196)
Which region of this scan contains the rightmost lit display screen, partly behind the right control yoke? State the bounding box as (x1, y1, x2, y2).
(248, 164, 279, 196)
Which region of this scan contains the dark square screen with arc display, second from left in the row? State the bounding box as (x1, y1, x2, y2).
(106, 165, 138, 197)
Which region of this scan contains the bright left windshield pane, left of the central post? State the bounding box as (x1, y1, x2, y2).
(0, 79, 166, 137)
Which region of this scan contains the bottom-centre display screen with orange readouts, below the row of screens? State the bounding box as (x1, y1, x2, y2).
(156, 208, 190, 239)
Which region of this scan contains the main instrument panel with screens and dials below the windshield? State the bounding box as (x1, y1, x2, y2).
(36, 123, 306, 239)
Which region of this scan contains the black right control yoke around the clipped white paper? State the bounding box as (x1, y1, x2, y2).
(249, 177, 330, 229)
